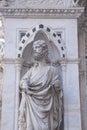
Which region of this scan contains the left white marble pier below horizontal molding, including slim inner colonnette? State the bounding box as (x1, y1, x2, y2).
(1, 58, 22, 130)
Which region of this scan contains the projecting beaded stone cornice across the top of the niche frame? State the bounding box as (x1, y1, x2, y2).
(0, 7, 84, 18)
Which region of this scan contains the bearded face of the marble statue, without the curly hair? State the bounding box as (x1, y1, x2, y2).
(33, 44, 43, 61)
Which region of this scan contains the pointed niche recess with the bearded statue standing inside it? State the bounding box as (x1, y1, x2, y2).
(18, 31, 63, 130)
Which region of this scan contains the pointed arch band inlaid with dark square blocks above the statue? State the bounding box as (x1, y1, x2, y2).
(17, 24, 66, 59)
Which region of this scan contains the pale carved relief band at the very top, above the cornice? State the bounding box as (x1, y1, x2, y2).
(1, 0, 79, 7)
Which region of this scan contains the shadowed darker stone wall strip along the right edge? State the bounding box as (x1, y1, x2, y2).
(78, 0, 87, 130)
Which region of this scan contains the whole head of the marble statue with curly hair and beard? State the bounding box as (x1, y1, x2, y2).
(33, 40, 48, 61)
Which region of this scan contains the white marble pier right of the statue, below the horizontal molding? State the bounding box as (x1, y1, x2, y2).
(65, 59, 82, 130)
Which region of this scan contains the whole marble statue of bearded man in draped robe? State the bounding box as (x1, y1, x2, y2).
(18, 40, 62, 130)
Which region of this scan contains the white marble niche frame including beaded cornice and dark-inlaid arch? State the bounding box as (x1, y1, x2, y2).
(0, 0, 84, 130)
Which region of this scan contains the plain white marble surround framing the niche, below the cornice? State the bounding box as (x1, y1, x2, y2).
(2, 18, 81, 130)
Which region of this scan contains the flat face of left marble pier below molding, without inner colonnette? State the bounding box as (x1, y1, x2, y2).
(1, 58, 16, 130)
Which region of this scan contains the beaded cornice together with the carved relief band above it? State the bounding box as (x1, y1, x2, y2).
(0, 0, 84, 18)
